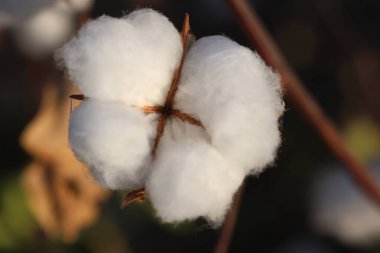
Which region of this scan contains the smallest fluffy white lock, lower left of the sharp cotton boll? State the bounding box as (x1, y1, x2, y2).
(69, 99, 156, 189)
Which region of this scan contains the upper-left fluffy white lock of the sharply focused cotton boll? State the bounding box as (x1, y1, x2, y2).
(58, 9, 182, 106)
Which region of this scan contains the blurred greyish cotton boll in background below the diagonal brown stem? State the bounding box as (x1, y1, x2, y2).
(310, 164, 380, 247)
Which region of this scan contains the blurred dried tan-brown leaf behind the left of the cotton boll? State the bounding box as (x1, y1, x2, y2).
(21, 85, 107, 242)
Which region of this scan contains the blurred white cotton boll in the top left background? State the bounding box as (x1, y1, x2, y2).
(0, 0, 93, 57)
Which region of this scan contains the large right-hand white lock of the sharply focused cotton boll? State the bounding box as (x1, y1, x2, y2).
(175, 36, 283, 174)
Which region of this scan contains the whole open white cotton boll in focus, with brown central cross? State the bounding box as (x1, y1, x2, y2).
(57, 9, 283, 224)
